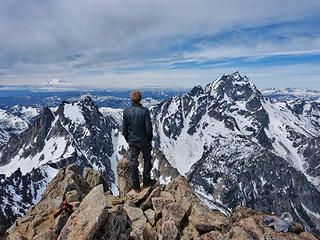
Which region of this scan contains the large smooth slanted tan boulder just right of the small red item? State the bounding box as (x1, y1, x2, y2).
(58, 184, 107, 240)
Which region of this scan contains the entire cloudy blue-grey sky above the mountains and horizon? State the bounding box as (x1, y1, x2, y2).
(0, 0, 320, 89)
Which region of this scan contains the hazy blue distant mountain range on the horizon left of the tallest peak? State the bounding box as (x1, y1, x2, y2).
(0, 86, 187, 109)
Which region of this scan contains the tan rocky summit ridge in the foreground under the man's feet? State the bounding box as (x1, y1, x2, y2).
(2, 158, 317, 240)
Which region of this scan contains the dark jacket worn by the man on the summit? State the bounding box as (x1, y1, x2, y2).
(122, 103, 152, 142)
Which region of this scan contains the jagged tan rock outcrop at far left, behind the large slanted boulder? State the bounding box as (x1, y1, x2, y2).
(1, 164, 105, 239)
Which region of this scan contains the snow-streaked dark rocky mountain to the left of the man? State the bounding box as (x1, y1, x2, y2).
(0, 97, 117, 231)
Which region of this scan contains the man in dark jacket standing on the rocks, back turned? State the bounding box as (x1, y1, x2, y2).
(122, 91, 155, 192)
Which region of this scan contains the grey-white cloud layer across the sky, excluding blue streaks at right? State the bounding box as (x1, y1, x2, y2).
(0, 0, 320, 86)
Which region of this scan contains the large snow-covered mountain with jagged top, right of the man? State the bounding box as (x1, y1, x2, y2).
(152, 72, 320, 234)
